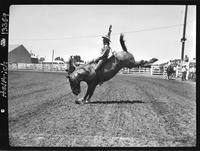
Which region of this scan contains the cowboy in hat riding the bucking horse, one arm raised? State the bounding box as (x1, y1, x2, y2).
(94, 25, 112, 85)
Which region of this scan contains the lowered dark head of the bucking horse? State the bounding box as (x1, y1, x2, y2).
(67, 72, 81, 95)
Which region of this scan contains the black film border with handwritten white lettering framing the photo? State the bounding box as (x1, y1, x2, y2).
(0, 0, 200, 150)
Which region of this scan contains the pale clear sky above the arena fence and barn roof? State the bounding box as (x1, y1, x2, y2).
(9, 5, 196, 63)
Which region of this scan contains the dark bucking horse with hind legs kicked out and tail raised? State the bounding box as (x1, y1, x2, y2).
(66, 34, 158, 104)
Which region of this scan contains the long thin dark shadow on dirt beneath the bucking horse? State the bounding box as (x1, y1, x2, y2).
(88, 100, 147, 104)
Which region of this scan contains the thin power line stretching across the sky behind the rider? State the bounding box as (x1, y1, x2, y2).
(10, 24, 183, 41)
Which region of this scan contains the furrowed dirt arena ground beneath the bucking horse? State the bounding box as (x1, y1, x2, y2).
(8, 71, 196, 147)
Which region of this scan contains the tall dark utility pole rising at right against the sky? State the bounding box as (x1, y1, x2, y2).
(181, 5, 188, 62)
